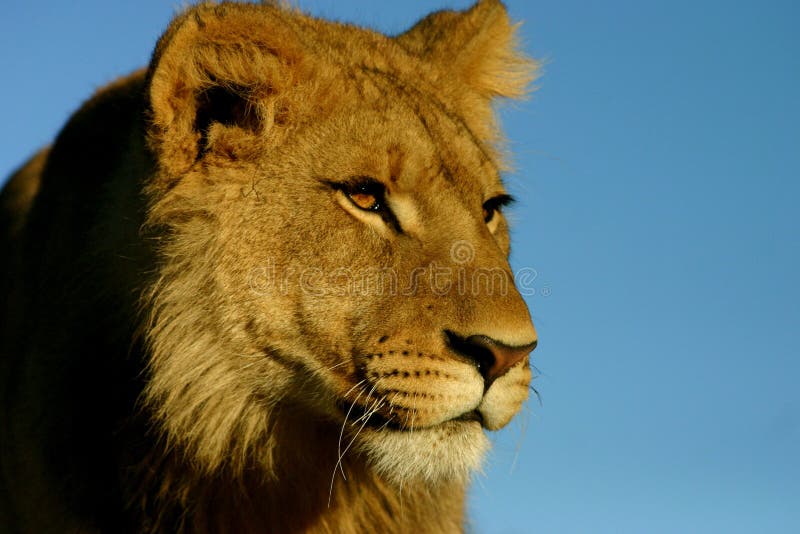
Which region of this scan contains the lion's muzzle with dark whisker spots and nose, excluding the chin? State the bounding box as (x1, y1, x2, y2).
(343, 320, 536, 430)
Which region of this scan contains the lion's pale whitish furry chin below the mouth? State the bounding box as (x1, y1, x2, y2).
(358, 420, 489, 487)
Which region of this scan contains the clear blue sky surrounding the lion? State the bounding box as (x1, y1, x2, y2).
(0, 0, 800, 534)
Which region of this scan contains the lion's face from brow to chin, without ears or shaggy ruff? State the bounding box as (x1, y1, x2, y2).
(239, 102, 536, 482)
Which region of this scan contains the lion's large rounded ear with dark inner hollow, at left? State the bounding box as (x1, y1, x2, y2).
(147, 4, 305, 176)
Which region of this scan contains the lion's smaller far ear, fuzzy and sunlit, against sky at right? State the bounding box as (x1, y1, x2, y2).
(397, 0, 536, 99)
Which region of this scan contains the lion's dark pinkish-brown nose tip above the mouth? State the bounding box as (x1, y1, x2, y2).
(445, 331, 537, 388)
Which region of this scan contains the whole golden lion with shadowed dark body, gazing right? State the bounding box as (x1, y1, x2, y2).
(0, 0, 537, 533)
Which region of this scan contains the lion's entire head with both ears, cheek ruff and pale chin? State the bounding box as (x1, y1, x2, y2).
(144, 1, 536, 488)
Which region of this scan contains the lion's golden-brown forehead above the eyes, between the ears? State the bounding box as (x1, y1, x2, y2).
(304, 75, 503, 198)
